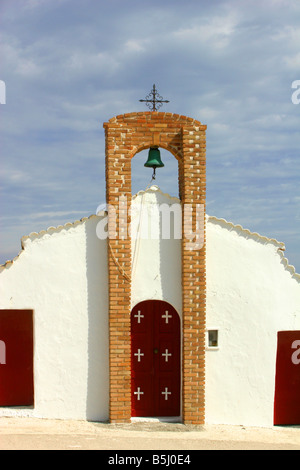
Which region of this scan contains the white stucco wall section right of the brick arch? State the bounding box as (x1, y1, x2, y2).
(206, 217, 300, 426)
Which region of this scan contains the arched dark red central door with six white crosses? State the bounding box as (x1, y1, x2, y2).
(131, 300, 180, 416)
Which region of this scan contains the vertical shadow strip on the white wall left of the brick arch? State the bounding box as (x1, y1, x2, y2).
(85, 216, 109, 421)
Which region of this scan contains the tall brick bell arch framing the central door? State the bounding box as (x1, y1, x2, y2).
(103, 111, 206, 424)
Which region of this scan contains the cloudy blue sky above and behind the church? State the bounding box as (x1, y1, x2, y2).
(0, 0, 300, 272)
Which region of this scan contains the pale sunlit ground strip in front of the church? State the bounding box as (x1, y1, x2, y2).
(0, 418, 300, 455)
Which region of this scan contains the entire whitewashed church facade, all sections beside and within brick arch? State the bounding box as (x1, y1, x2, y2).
(0, 188, 300, 426)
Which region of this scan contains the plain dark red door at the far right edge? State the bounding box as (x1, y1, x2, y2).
(274, 331, 300, 425)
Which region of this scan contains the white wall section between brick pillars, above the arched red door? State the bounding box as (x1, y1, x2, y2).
(131, 187, 182, 317)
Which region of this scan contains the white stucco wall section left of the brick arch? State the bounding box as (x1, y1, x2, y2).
(0, 216, 108, 420)
